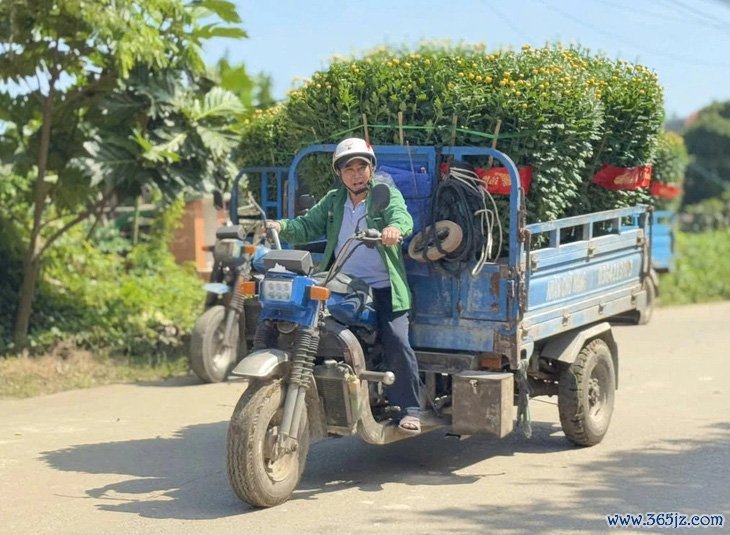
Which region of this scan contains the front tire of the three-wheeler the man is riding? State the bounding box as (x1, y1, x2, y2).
(226, 382, 309, 507)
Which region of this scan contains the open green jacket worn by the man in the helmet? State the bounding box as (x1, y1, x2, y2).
(279, 181, 413, 312)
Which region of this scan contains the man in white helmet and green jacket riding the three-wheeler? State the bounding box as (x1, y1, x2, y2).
(267, 138, 421, 434)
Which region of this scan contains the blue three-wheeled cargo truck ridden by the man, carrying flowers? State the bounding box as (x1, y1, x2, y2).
(219, 145, 654, 507)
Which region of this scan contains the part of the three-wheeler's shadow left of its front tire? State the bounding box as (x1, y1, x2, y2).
(43, 422, 236, 519)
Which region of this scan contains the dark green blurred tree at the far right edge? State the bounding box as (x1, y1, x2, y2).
(684, 101, 730, 205)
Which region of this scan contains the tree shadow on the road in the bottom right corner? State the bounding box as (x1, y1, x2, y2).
(416, 423, 730, 533)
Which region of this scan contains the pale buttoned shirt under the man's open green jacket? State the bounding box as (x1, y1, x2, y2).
(335, 196, 390, 288)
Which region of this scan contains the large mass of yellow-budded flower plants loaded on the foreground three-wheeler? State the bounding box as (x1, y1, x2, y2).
(236, 39, 663, 228)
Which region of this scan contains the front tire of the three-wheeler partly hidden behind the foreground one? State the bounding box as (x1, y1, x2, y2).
(190, 305, 239, 383)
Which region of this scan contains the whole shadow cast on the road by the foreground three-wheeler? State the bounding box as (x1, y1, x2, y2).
(42, 422, 570, 519)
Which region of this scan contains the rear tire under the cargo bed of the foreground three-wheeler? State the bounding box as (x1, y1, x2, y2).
(558, 339, 616, 446)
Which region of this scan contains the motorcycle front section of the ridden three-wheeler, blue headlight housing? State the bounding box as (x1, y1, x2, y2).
(227, 185, 432, 507)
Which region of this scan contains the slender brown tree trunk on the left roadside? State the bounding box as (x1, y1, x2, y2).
(13, 92, 54, 350)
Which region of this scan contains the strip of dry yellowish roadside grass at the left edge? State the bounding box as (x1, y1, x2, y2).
(0, 346, 189, 399)
